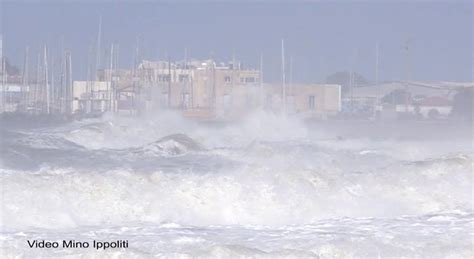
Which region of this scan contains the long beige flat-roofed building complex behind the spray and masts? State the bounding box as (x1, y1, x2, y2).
(74, 60, 341, 118)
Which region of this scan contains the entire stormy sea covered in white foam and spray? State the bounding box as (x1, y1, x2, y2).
(0, 112, 474, 258)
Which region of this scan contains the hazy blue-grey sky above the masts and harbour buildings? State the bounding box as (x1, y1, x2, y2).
(1, 1, 473, 82)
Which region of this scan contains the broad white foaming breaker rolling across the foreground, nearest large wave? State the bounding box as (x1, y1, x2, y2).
(1, 150, 472, 232)
